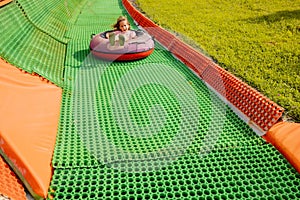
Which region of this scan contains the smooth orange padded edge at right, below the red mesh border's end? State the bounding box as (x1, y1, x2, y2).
(264, 122, 300, 173)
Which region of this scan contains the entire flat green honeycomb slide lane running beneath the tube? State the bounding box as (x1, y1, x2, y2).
(49, 0, 300, 199)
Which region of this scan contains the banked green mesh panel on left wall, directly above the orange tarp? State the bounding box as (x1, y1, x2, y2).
(0, 1, 66, 86)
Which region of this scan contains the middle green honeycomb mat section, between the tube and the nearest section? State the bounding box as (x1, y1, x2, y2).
(53, 60, 263, 167)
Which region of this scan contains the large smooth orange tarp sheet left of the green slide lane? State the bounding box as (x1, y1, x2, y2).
(0, 59, 62, 197)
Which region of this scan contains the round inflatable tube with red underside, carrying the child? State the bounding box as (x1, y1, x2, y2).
(90, 30, 154, 61)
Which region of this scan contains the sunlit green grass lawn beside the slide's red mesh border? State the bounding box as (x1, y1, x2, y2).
(135, 0, 300, 122)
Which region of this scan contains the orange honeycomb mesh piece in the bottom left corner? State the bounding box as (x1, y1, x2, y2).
(0, 156, 26, 200)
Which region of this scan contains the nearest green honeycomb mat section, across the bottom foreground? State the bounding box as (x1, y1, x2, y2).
(49, 144, 300, 200)
